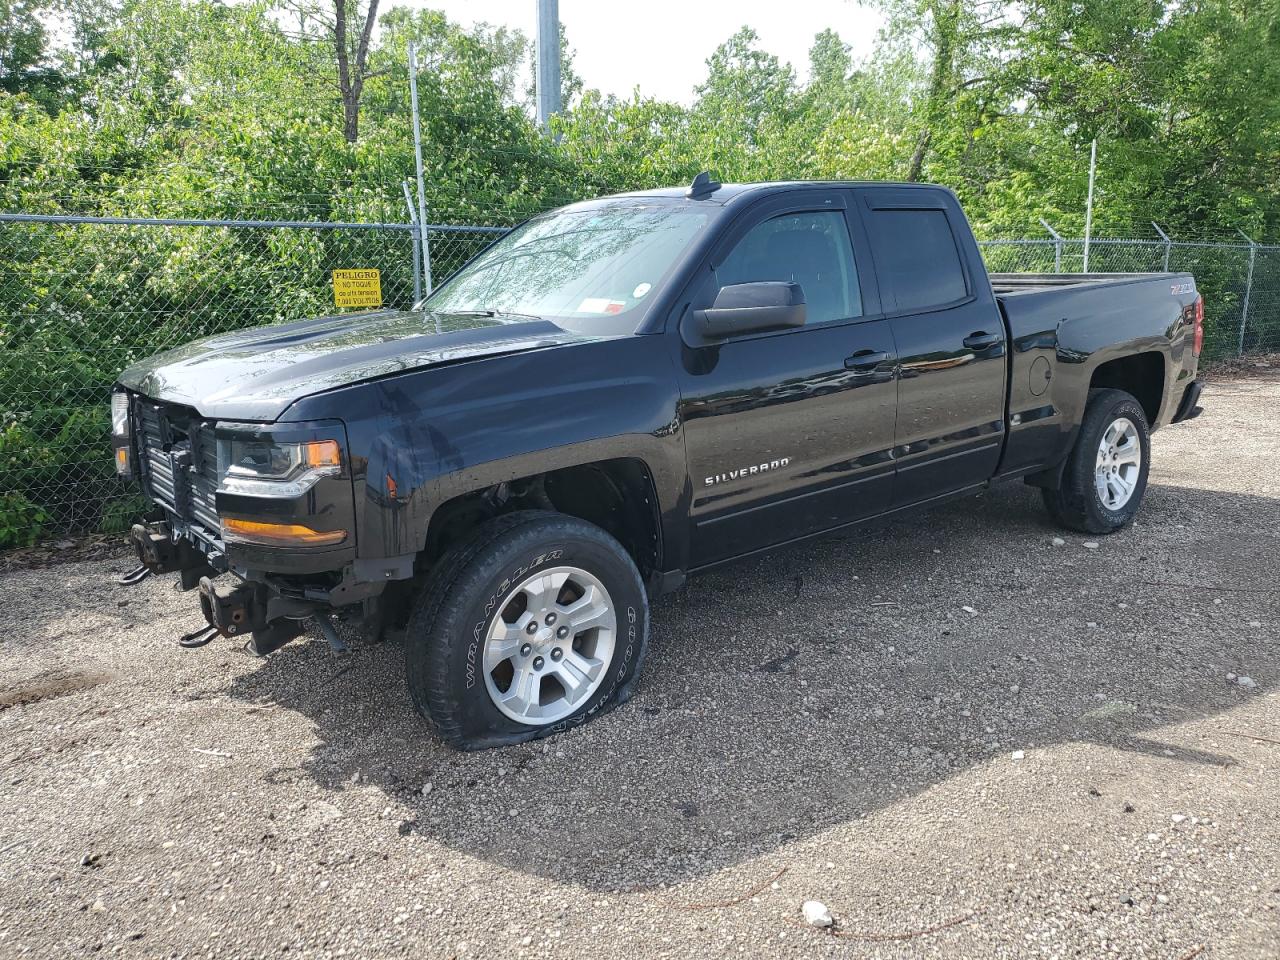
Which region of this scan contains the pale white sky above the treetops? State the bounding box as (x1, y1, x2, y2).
(414, 0, 881, 104)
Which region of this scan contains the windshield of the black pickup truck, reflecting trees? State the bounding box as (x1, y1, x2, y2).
(424, 202, 708, 333)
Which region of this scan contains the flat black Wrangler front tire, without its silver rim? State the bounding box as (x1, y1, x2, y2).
(404, 511, 649, 750)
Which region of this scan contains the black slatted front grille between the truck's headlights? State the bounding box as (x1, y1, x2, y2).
(133, 397, 221, 538)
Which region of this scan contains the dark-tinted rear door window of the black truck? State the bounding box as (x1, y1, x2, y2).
(872, 210, 969, 310)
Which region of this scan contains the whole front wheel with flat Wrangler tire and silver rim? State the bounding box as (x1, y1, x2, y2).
(404, 511, 649, 750)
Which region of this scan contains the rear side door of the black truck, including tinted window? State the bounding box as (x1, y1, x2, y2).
(856, 187, 1006, 507)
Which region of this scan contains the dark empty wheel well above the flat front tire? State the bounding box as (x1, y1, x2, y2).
(422, 458, 662, 579)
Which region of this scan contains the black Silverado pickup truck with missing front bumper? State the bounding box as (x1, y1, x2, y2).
(111, 174, 1203, 749)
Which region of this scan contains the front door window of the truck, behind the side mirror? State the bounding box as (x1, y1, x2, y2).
(716, 211, 863, 325)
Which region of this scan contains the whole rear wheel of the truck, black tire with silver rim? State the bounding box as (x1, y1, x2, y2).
(1042, 389, 1151, 534)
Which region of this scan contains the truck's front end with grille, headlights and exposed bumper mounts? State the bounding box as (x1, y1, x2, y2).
(113, 392, 415, 654)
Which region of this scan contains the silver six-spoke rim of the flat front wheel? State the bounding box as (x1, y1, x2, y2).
(483, 567, 617, 726)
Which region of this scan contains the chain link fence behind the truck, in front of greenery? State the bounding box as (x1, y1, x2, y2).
(0, 214, 1280, 547)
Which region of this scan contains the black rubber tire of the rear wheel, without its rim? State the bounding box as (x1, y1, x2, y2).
(1041, 389, 1151, 536)
